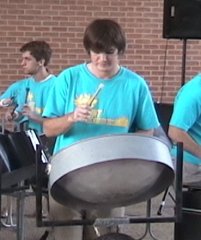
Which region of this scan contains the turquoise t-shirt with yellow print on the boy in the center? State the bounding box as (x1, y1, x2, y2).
(43, 64, 159, 153)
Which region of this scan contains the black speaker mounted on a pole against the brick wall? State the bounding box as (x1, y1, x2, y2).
(163, 0, 201, 39)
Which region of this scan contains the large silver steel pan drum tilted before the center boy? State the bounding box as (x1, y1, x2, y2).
(49, 134, 174, 209)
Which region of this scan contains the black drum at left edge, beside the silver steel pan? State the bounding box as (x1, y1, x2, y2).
(0, 130, 48, 188)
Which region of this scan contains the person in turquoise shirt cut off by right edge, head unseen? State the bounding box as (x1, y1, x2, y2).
(169, 74, 201, 183)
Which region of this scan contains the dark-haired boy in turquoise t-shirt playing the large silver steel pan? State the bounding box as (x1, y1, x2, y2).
(43, 19, 159, 240)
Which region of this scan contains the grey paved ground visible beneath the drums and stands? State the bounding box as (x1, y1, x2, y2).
(0, 189, 176, 240)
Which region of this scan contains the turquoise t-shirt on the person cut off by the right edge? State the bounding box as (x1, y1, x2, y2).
(170, 74, 201, 164)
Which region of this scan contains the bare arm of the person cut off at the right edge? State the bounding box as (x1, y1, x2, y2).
(168, 126, 201, 158)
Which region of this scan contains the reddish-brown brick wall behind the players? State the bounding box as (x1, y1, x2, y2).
(0, 0, 201, 107)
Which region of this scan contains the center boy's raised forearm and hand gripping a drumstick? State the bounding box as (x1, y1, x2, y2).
(43, 105, 91, 137)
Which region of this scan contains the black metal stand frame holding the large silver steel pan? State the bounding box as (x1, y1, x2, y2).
(35, 143, 183, 240)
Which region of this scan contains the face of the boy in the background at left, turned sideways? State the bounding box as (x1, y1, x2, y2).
(21, 51, 43, 75)
